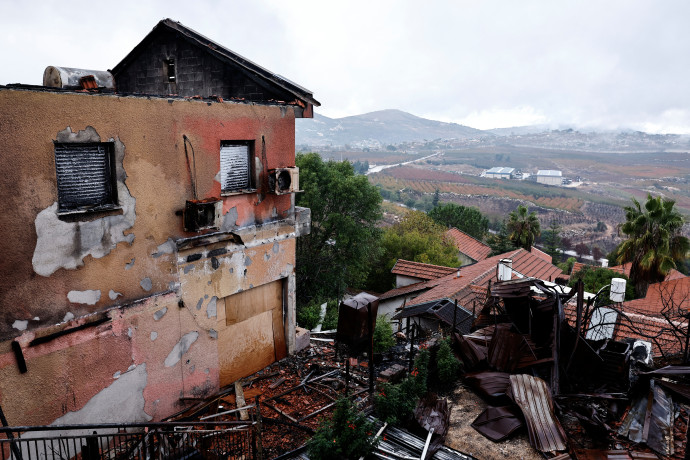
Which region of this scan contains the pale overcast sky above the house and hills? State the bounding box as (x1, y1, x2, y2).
(0, 0, 690, 133)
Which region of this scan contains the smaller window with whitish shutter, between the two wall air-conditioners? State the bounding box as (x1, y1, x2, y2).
(220, 141, 256, 194)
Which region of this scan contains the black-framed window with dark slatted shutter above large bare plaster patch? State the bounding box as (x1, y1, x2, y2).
(55, 142, 118, 213)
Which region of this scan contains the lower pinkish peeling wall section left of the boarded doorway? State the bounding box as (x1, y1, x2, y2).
(0, 293, 218, 425)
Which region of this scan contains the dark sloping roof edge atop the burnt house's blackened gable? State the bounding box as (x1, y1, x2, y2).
(111, 19, 321, 106)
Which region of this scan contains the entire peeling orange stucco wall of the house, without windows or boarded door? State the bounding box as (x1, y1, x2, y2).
(0, 87, 299, 425)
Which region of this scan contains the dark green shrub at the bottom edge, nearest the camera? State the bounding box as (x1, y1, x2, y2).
(307, 398, 378, 460)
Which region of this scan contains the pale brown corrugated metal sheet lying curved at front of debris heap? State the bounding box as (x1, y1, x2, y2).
(510, 374, 568, 452)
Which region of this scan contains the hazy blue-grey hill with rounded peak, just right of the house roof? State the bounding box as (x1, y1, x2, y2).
(295, 110, 486, 148)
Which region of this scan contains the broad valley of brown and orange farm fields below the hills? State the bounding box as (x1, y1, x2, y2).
(310, 141, 690, 252)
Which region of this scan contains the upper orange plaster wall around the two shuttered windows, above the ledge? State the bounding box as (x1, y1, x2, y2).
(0, 87, 294, 338)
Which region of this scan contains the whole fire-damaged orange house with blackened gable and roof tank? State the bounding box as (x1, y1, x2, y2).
(0, 19, 319, 426)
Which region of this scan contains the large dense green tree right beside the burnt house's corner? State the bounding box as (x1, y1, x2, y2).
(296, 153, 381, 304)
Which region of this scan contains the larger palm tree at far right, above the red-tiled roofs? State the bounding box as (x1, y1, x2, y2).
(616, 194, 690, 297)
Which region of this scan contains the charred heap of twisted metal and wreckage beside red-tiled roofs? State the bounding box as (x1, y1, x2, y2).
(454, 279, 690, 459)
